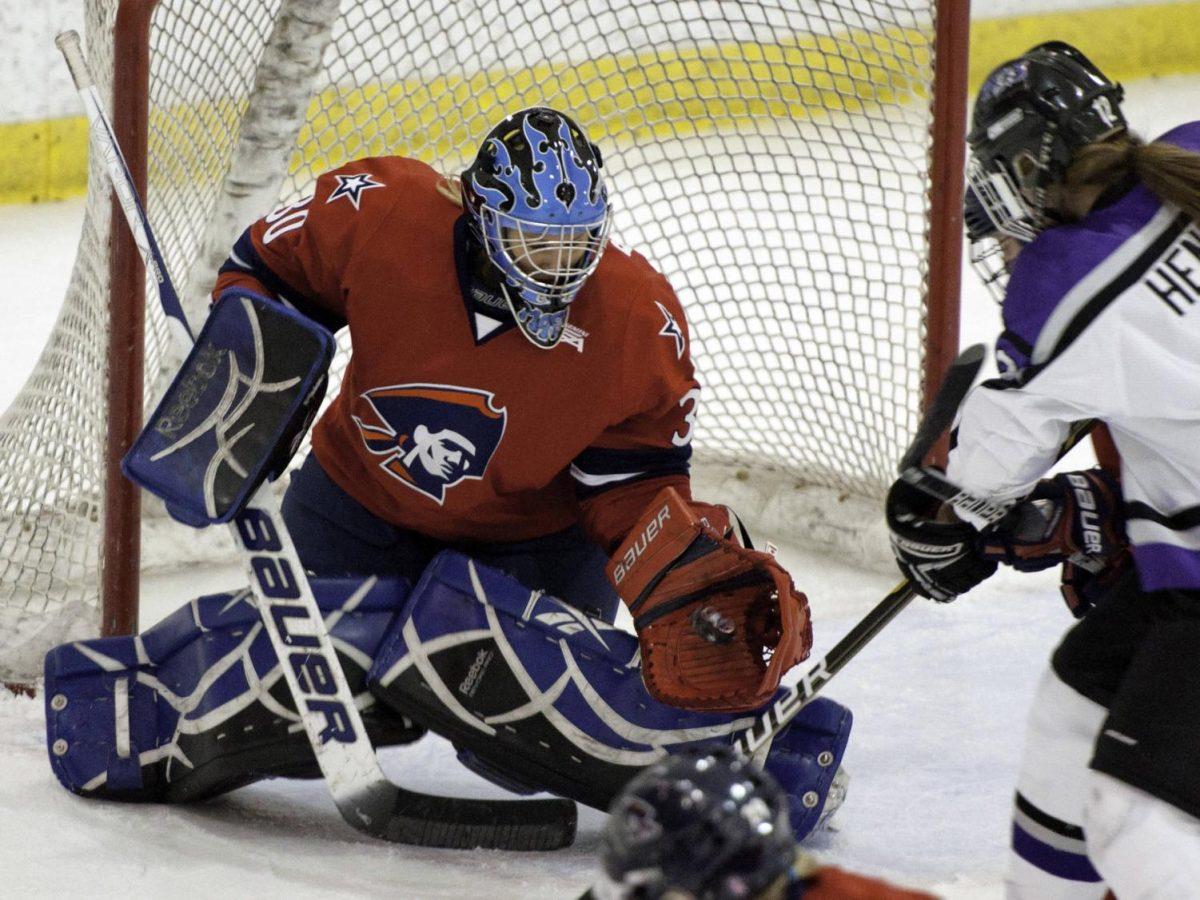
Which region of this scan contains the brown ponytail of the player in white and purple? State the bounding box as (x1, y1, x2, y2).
(1064, 132, 1200, 222)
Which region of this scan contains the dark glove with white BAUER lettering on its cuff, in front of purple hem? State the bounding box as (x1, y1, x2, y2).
(982, 469, 1128, 572)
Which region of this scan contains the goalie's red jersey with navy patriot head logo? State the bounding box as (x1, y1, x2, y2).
(214, 157, 698, 551)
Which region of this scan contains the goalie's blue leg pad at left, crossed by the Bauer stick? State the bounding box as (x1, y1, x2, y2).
(46, 578, 424, 802)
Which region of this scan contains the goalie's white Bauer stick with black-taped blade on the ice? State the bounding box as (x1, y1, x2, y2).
(55, 31, 576, 850)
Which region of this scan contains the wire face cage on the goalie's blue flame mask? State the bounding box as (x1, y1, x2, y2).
(480, 206, 612, 312)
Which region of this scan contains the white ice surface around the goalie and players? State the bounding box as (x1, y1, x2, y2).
(0, 72, 1200, 900)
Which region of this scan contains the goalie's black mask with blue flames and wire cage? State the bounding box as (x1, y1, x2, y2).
(462, 107, 612, 349)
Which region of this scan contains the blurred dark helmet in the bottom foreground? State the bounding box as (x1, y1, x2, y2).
(592, 746, 796, 900)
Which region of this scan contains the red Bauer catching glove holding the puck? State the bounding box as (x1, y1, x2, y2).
(607, 487, 812, 712)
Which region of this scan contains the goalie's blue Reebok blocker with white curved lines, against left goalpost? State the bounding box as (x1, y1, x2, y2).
(121, 290, 334, 527)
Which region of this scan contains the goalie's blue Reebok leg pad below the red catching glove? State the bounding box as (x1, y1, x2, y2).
(368, 551, 852, 836)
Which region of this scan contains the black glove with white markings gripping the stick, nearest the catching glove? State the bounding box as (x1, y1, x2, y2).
(887, 479, 996, 604)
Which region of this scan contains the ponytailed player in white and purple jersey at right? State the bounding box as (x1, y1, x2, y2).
(888, 42, 1200, 899)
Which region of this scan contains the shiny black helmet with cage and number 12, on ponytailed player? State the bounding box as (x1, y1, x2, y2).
(967, 41, 1127, 241)
